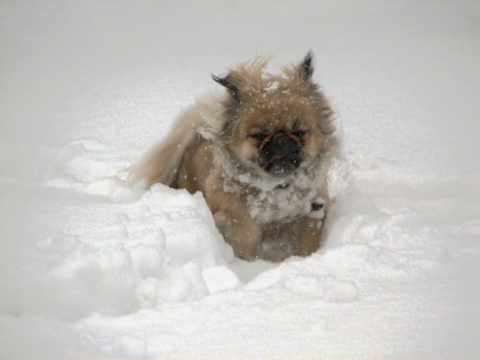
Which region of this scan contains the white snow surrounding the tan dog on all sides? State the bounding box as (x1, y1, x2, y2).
(0, 0, 480, 360)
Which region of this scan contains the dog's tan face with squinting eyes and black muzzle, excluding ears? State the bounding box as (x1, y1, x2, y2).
(228, 92, 321, 177)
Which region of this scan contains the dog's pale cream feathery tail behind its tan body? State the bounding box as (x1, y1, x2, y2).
(130, 103, 211, 187)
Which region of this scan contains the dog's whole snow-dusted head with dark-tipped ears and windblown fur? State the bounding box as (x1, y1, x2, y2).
(213, 53, 334, 178)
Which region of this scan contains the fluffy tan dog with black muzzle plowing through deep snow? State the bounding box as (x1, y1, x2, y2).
(134, 52, 338, 261)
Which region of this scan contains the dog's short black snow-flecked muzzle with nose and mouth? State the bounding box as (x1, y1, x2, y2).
(259, 133, 302, 177)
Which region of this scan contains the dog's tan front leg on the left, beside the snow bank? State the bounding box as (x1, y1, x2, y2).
(205, 170, 261, 260)
